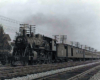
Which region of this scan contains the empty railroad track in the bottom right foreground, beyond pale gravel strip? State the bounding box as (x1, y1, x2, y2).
(35, 61, 100, 80)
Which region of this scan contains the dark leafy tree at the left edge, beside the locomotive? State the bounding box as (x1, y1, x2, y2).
(0, 25, 11, 65)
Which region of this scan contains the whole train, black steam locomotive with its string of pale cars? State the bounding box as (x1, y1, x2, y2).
(0, 25, 100, 65)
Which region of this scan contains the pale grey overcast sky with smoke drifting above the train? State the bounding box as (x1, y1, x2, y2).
(0, 0, 100, 51)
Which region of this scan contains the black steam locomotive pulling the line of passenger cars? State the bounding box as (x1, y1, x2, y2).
(11, 24, 56, 65)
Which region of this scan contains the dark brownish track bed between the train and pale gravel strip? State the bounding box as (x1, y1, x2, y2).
(0, 61, 99, 80)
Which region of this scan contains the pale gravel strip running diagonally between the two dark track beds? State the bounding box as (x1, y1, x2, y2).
(5, 61, 100, 80)
